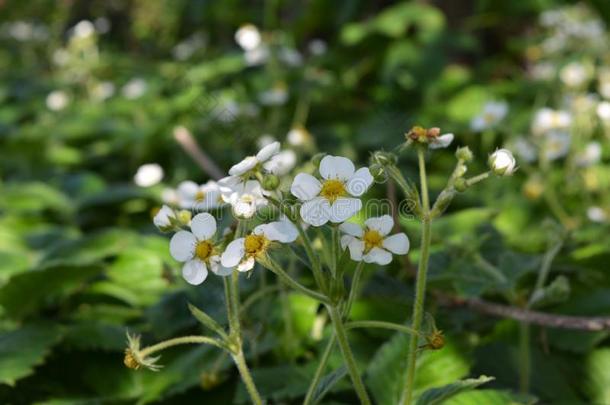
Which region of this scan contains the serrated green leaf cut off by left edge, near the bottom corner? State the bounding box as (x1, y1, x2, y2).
(0, 325, 61, 385)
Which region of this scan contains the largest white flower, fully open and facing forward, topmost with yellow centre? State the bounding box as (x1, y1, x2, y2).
(290, 156, 373, 226)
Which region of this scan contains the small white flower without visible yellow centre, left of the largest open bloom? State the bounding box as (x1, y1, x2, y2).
(218, 176, 268, 218)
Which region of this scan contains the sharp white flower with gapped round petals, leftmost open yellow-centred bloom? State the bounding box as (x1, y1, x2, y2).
(169, 212, 231, 285)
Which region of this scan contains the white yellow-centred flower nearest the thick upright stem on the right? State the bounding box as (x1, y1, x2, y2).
(339, 215, 409, 266)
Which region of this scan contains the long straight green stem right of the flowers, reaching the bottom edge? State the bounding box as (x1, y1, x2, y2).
(400, 147, 432, 405)
